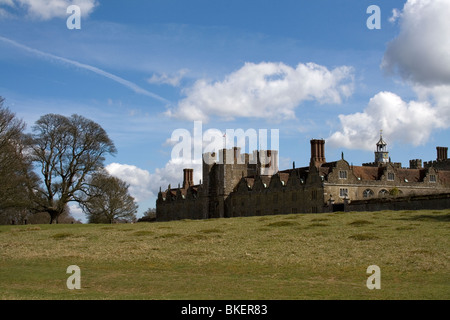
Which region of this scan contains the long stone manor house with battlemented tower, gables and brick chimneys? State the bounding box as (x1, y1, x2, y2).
(156, 134, 450, 221)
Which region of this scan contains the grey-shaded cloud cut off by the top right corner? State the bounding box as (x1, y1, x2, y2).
(381, 0, 450, 86)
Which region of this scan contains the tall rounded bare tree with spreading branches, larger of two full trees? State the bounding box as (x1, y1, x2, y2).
(31, 114, 117, 223)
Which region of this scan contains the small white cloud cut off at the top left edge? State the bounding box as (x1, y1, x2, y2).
(0, 0, 98, 20)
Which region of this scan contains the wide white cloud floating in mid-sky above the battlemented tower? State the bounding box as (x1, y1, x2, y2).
(167, 62, 353, 122)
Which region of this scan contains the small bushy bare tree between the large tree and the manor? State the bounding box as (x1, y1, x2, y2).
(80, 171, 138, 223)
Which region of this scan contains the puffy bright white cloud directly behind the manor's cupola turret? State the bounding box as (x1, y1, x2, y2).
(327, 92, 442, 150)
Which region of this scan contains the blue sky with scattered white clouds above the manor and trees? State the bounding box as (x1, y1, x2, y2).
(0, 0, 450, 220)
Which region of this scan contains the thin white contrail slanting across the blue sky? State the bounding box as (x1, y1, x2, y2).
(0, 36, 170, 103)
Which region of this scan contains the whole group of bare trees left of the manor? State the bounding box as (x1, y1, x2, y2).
(0, 97, 138, 224)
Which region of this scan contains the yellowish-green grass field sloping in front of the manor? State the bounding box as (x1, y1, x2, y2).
(0, 210, 450, 300)
